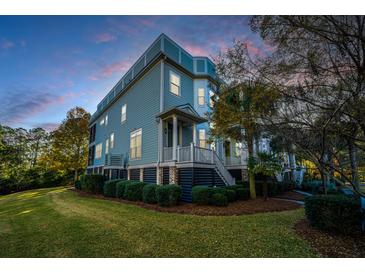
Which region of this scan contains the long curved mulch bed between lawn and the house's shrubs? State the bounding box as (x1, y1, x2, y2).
(74, 190, 302, 216)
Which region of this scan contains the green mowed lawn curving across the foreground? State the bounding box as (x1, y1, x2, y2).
(0, 188, 317, 257)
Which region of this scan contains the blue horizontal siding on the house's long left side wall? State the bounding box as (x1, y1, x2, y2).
(94, 63, 161, 166)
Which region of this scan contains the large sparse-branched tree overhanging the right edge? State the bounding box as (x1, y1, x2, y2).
(251, 16, 365, 195)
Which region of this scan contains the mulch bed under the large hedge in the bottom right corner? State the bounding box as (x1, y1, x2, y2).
(294, 220, 365, 258)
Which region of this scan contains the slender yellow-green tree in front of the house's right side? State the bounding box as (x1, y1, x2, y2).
(211, 41, 279, 199)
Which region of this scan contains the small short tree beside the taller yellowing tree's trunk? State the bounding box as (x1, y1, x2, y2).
(253, 152, 281, 201)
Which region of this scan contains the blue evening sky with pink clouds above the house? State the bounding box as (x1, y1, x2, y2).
(0, 16, 264, 129)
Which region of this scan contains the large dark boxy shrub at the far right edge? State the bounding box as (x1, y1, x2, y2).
(305, 195, 361, 234)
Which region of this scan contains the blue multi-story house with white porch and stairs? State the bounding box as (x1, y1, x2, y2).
(87, 34, 247, 201)
